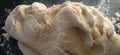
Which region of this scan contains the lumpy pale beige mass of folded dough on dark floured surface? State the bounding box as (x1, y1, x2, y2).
(5, 2, 120, 55)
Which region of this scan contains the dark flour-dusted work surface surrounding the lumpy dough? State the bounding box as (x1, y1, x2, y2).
(0, 0, 120, 55)
